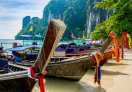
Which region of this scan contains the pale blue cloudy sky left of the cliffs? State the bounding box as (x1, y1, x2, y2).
(0, 0, 50, 39)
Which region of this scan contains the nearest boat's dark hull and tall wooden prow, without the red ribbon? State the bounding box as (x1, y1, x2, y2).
(0, 20, 66, 92)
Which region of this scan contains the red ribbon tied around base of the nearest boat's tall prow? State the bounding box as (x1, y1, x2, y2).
(30, 67, 46, 92)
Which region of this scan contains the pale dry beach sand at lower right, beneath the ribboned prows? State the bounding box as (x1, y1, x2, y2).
(81, 50, 132, 92)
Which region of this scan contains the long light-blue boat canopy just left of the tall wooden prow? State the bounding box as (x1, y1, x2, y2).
(8, 45, 41, 51)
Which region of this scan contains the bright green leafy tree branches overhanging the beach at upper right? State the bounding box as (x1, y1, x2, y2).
(95, 0, 132, 39)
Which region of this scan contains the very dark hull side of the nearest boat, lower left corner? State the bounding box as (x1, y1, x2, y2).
(0, 77, 35, 92)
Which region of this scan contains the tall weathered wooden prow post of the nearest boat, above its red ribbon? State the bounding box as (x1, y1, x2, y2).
(34, 20, 66, 73)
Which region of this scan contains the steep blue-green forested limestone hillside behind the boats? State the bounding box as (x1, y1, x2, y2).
(16, 0, 109, 40)
